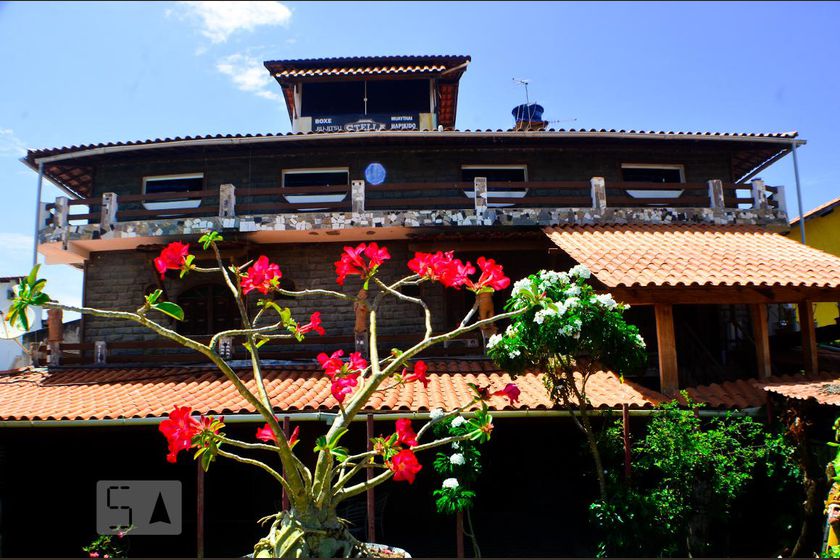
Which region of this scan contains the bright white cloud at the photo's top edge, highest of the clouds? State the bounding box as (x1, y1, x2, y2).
(174, 2, 292, 43)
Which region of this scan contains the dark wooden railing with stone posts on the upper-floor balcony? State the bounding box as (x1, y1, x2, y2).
(39, 177, 785, 229)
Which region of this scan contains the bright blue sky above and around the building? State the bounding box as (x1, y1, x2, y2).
(0, 2, 840, 310)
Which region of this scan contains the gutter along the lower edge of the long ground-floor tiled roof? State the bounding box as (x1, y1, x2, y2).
(0, 407, 761, 428)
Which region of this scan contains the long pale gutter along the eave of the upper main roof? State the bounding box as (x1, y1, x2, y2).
(31, 130, 806, 169)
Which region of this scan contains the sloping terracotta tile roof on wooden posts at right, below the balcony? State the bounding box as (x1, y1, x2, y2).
(545, 224, 840, 288)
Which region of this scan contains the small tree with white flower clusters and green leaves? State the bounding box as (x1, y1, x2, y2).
(487, 265, 647, 499)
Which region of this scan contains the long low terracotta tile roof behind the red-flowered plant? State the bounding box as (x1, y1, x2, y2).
(0, 360, 665, 420)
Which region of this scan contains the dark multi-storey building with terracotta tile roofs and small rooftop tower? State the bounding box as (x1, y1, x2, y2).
(0, 56, 840, 556)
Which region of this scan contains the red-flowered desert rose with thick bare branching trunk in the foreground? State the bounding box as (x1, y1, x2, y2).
(6, 232, 529, 557)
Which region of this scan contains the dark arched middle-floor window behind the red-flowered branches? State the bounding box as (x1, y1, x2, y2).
(177, 284, 241, 335)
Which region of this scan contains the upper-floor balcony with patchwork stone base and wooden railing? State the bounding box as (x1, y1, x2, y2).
(38, 177, 787, 264)
